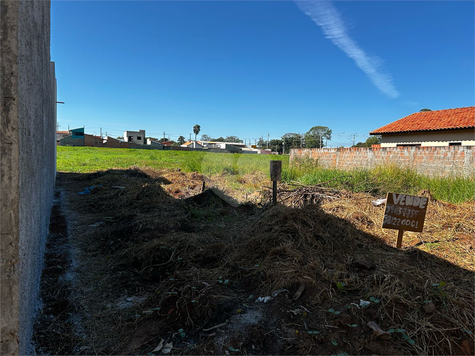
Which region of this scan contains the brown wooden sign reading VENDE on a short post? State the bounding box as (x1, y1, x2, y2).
(383, 193, 429, 248)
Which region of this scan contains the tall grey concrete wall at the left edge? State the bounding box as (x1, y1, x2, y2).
(0, 0, 56, 355)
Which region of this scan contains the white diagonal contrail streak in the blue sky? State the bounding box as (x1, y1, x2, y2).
(295, 0, 399, 98)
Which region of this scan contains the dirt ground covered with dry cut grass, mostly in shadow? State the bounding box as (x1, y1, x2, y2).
(35, 169, 475, 355)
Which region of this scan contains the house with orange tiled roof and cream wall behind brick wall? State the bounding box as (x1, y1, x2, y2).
(370, 106, 475, 147)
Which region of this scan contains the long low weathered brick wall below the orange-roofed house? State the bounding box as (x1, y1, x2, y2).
(290, 146, 475, 176)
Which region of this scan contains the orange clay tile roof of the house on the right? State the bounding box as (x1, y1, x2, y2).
(370, 106, 475, 135)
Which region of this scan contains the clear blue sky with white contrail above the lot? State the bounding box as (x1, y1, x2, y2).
(51, 0, 475, 147)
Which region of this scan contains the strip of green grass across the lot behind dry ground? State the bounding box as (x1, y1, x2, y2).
(57, 146, 475, 203)
